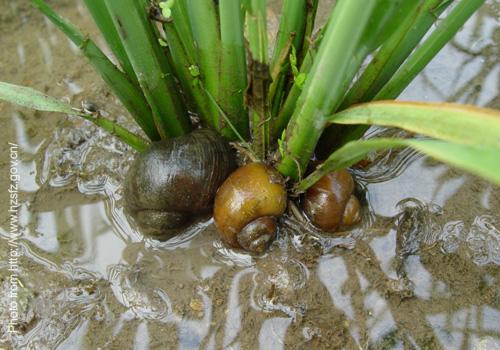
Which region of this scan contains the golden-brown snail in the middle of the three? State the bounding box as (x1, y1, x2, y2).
(214, 163, 287, 253)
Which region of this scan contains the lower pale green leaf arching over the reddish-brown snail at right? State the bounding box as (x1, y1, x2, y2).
(295, 138, 500, 193)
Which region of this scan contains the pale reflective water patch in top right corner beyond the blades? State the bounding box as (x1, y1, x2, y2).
(402, 0, 500, 108)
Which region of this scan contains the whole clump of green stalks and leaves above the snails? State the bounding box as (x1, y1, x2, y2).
(0, 0, 500, 192)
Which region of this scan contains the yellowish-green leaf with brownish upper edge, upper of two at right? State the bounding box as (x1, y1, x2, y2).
(328, 101, 500, 145)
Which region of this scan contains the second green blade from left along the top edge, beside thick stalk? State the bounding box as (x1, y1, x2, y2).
(84, 0, 139, 80)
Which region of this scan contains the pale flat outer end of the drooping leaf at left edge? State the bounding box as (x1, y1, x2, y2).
(0, 82, 79, 114)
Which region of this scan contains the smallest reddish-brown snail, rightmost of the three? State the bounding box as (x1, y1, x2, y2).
(303, 170, 361, 231)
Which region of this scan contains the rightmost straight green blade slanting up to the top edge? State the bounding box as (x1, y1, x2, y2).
(374, 0, 484, 100)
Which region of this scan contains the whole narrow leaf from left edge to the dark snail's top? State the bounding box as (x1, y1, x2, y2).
(0, 82, 147, 152)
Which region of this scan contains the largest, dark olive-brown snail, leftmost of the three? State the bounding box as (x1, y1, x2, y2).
(124, 129, 235, 237)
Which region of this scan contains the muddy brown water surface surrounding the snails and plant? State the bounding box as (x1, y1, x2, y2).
(0, 0, 500, 349)
